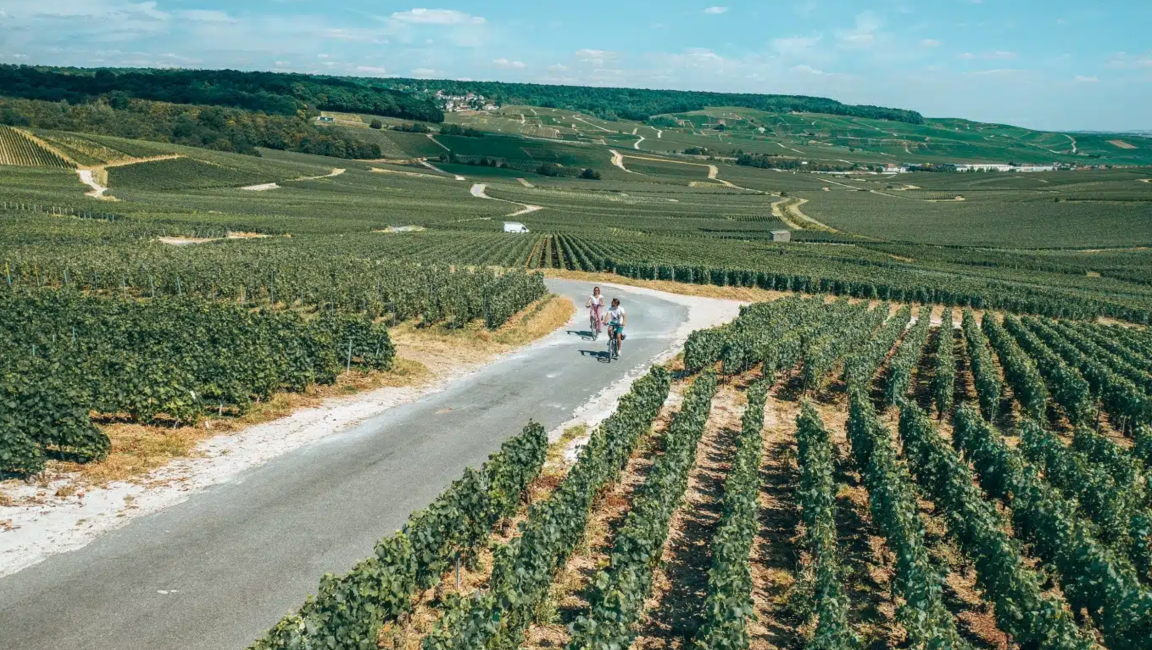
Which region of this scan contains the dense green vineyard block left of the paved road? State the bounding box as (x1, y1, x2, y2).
(0, 264, 547, 475)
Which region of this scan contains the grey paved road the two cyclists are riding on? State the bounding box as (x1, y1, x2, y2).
(0, 280, 688, 650)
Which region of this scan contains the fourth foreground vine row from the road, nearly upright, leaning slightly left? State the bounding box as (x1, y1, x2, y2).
(692, 376, 772, 650)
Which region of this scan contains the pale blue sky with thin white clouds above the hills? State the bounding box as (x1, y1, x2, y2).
(0, 0, 1152, 130)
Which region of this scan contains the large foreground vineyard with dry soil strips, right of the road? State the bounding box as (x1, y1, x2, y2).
(226, 295, 1152, 650)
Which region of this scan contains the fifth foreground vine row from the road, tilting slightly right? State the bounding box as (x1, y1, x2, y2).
(796, 403, 861, 650)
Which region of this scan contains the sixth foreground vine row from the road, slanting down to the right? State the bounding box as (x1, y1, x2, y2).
(848, 391, 969, 650)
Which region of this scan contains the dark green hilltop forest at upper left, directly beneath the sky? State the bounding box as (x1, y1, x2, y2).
(0, 66, 444, 122)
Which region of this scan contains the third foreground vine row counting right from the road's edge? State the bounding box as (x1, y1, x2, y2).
(568, 372, 717, 650)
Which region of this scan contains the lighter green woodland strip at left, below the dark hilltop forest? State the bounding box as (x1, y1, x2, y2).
(0, 97, 380, 158)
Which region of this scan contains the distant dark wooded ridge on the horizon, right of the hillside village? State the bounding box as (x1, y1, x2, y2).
(382, 78, 924, 124)
